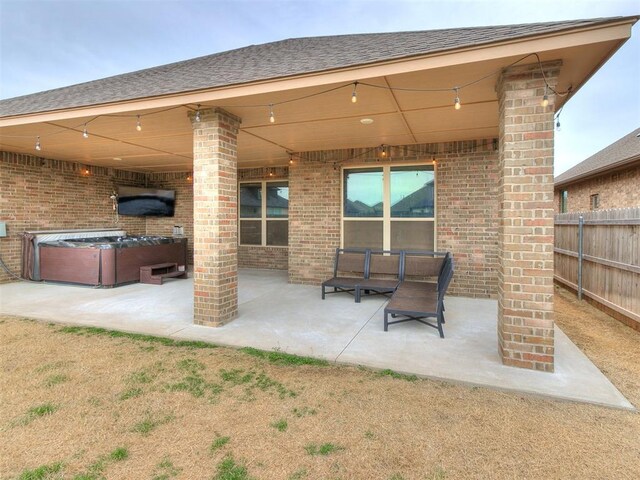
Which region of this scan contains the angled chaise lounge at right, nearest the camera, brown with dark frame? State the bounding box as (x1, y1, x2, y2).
(384, 255, 454, 338)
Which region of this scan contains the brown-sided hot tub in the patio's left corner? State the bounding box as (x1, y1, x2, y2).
(39, 236, 187, 287)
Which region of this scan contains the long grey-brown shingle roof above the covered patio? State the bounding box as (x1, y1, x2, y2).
(0, 17, 626, 117)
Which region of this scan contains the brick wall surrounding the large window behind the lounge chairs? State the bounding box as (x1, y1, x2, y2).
(289, 140, 498, 297)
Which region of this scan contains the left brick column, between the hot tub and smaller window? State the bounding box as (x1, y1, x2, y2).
(190, 108, 240, 327)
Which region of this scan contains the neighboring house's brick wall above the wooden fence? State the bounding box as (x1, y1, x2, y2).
(553, 164, 640, 213)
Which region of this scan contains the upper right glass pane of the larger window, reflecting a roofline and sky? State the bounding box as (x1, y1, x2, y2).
(391, 167, 434, 218)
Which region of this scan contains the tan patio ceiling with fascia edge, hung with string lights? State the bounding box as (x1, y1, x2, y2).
(0, 20, 632, 172)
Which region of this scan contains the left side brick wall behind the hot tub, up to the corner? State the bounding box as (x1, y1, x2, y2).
(0, 152, 146, 283)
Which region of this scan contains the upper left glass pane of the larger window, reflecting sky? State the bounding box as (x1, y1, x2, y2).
(344, 168, 383, 217)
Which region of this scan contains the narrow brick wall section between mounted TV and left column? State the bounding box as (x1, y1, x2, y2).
(146, 172, 193, 264)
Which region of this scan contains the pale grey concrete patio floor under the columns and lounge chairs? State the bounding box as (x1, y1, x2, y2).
(0, 270, 634, 410)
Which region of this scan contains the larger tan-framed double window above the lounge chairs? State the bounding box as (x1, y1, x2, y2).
(342, 165, 435, 250)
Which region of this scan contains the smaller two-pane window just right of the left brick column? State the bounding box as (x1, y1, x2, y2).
(238, 181, 289, 247)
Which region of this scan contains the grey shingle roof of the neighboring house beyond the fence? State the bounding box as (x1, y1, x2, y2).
(555, 128, 640, 187)
